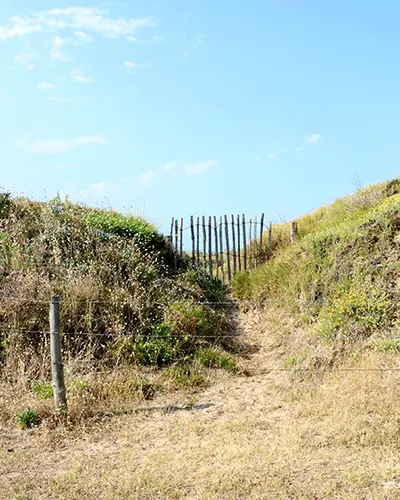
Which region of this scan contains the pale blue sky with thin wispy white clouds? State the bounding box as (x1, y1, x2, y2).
(0, 0, 400, 234)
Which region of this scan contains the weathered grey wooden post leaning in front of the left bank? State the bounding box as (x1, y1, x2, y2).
(50, 296, 67, 413)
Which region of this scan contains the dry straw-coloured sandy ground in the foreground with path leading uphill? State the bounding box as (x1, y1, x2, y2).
(0, 314, 400, 500)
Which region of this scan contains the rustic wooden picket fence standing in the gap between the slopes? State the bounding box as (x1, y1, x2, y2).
(169, 214, 272, 282)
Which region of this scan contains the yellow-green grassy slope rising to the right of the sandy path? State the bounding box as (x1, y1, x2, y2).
(233, 180, 400, 349)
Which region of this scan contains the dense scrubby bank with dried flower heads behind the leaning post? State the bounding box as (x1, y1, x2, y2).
(0, 194, 233, 424)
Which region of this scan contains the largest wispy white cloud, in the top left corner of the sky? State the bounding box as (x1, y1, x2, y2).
(0, 7, 157, 41)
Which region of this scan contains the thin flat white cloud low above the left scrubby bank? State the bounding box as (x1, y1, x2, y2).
(18, 135, 110, 155)
